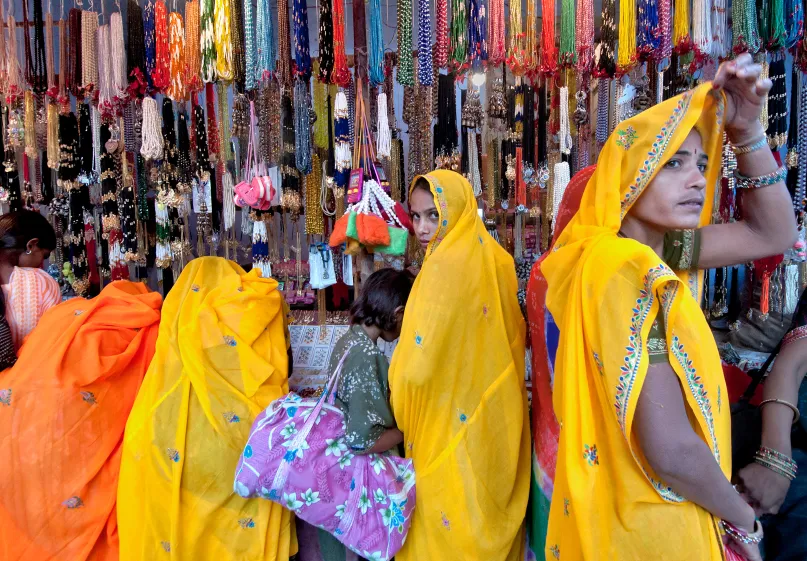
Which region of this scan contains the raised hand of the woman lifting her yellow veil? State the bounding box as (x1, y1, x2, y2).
(712, 53, 773, 145)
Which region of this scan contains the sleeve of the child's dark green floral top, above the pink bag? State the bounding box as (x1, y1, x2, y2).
(337, 346, 395, 452)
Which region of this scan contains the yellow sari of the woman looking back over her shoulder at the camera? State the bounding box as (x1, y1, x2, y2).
(389, 171, 530, 561)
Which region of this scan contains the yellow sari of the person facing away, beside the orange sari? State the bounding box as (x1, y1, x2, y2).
(118, 257, 296, 561)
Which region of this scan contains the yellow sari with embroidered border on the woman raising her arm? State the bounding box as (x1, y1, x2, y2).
(541, 84, 731, 561)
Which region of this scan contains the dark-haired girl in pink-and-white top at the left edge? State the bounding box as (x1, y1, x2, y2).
(0, 210, 61, 350)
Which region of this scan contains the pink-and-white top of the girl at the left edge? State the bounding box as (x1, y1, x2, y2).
(3, 267, 62, 351)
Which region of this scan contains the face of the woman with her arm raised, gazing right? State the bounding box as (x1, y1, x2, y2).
(629, 129, 717, 231)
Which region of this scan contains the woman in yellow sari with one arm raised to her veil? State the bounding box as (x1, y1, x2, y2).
(541, 55, 795, 561)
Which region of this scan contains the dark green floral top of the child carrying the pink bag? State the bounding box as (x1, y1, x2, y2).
(328, 325, 395, 452)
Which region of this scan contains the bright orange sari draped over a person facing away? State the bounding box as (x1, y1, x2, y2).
(0, 281, 162, 561)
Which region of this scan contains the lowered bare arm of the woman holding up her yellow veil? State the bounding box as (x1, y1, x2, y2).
(634, 363, 761, 561)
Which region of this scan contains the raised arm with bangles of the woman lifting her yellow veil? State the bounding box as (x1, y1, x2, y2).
(698, 54, 796, 269)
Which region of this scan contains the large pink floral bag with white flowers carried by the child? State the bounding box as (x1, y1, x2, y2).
(234, 347, 415, 561)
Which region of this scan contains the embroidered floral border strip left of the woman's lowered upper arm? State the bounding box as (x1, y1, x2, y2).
(614, 263, 675, 437)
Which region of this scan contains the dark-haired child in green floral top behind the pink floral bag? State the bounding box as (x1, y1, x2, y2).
(297, 269, 413, 561)
